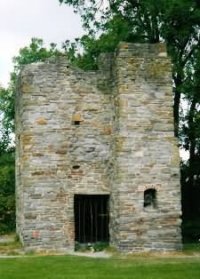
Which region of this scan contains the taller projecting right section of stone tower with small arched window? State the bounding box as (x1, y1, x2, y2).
(111, 44, 181, 251)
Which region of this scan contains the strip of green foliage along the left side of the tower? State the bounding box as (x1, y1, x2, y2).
(0, 87, 15, 234)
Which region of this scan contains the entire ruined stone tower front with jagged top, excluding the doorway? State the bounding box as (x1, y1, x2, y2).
(16, 43, 181, 252)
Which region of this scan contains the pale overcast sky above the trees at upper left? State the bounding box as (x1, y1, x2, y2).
(0, 0, 82, 86)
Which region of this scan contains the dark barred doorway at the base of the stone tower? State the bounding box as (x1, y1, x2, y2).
(74, 195, 109, 243)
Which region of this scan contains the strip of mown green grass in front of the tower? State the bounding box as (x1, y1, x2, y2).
(0, 256, 200, 279)
